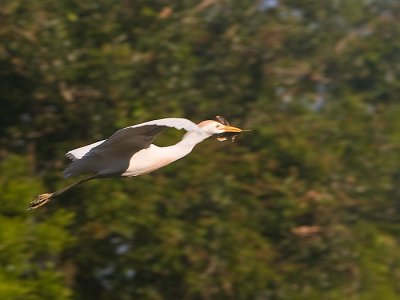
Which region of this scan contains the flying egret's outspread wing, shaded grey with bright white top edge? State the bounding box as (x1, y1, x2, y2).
(64, 118, 200, 177)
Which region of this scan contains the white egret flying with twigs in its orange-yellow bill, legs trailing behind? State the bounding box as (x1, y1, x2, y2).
(28, 116, 247, 210)
